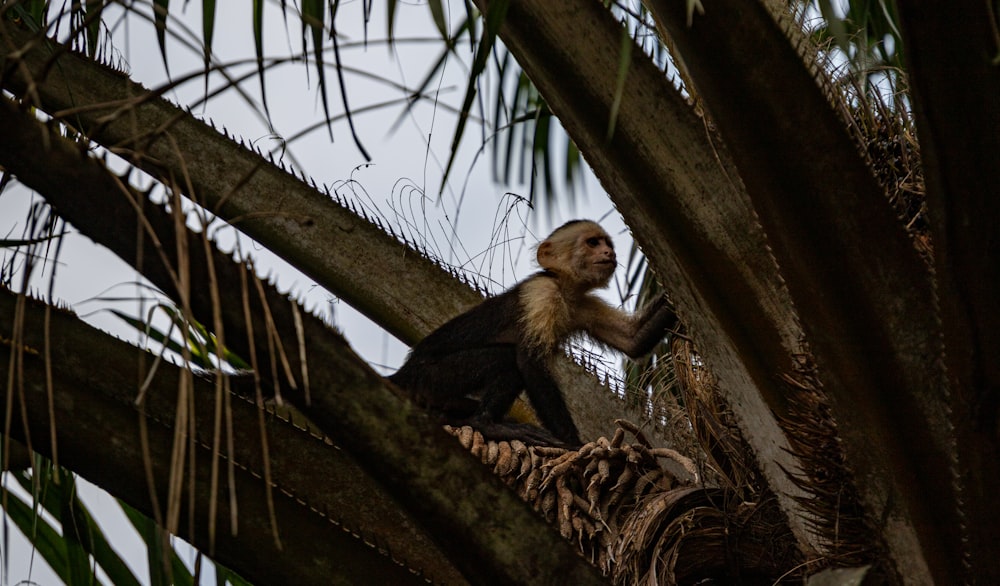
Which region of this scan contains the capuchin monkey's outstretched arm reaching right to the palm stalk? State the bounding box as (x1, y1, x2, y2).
(580, 296, 677, 358)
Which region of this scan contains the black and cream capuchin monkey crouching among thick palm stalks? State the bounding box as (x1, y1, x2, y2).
(389, 220, 677, 447)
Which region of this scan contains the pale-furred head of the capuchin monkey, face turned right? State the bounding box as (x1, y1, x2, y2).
(537, 220, 618, 290)
